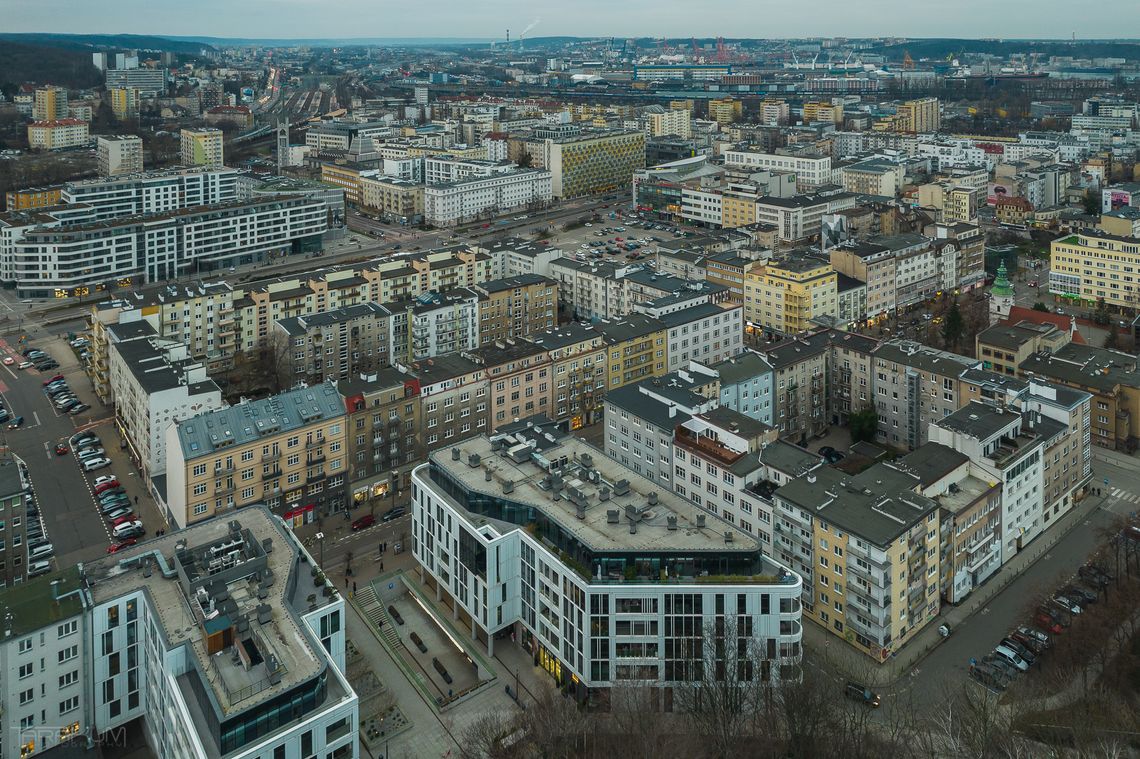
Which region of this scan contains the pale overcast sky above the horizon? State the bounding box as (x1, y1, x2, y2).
(2, 0, 1140, 40)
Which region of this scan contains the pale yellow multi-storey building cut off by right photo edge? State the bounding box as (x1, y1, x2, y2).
(1049, 229, 1140, 310)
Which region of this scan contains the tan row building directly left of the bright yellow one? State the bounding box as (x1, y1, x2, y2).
(530, 321, 608, 432)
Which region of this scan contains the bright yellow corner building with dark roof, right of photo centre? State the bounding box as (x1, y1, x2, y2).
(744, 252, 839, 335)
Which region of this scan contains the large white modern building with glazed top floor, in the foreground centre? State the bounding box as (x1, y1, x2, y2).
(413, 422, 800, 708)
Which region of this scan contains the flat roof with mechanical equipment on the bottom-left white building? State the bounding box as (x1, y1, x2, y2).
(83, 505, 335, 718)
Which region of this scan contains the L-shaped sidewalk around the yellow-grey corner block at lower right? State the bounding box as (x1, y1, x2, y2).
(804, 494, 1103, 687)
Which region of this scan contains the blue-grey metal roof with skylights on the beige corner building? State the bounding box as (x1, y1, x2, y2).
(178, 382, 344, 460)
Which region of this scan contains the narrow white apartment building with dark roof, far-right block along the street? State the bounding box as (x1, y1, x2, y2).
(929, 401, 1057, 564)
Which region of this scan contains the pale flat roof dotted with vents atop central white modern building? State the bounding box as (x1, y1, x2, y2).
(430, 433, 759, 554)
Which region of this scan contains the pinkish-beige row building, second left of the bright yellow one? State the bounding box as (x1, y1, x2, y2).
(463, 338, 554, 432)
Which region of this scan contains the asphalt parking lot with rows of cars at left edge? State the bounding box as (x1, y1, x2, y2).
(0, 328, 163, 566)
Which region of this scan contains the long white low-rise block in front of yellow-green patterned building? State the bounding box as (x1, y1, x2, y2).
(424, 169, 552, 227)
